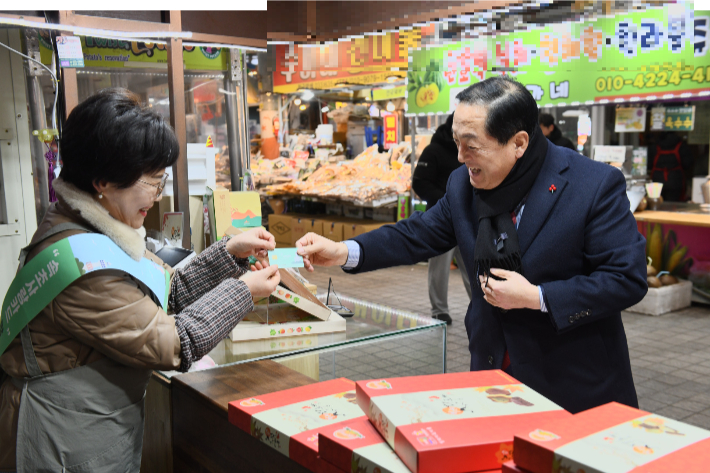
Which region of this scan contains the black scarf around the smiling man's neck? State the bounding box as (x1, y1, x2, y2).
(474, 127, 547, 282)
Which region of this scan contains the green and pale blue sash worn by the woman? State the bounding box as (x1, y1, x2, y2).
(0, 233, 170, 355)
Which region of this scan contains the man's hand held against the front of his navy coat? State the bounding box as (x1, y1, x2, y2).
(479, 268, 540, 310)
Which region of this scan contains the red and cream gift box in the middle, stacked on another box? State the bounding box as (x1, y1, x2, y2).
(356, 370, 576, 473)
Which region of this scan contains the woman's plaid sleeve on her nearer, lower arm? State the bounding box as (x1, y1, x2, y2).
(175, 278, 254, 372)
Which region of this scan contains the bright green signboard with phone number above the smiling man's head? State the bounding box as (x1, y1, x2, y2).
(407, 3, 710, 115)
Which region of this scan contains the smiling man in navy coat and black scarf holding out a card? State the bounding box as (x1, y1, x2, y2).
(297, 77, 648, 412)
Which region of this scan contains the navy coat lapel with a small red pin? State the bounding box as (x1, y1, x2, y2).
(518, 145, 569, 255)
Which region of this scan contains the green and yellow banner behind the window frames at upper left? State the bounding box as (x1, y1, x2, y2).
(39, 31, 229, 71)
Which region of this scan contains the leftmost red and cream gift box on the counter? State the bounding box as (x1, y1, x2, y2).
(229, 378, 363, 471)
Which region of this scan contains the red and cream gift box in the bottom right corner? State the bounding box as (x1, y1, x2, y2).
(515, 402, 710, 473)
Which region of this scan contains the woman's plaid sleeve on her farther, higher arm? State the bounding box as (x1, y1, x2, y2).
(168, 238, 249, 314)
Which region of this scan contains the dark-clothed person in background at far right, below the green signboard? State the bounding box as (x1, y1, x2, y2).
(648, 131, 693, 202)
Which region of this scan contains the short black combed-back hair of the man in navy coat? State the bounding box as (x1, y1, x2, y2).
(456, 76, 538, 144)
